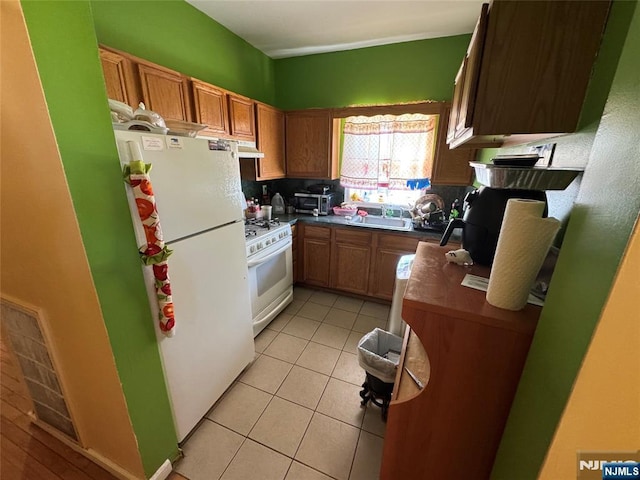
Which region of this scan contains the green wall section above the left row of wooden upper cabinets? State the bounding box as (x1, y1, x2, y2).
(91, 0, 275, 105)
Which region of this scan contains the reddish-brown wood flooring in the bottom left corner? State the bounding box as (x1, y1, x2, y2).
(0, 341, 188, 480)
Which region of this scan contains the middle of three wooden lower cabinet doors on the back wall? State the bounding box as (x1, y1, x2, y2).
(331, 228, 373, 295)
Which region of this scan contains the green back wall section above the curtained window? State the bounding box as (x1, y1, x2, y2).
(275, 34, 470, 110)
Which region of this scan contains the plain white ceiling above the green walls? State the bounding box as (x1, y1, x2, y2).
(182, 0, 486, 58)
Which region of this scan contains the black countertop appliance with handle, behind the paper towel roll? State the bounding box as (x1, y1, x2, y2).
(440, 187, 548, 266)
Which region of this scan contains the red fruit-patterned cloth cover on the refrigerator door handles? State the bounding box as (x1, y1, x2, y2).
(123, 154, 175, 337)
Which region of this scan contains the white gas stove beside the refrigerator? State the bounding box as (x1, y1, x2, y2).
(245, 219, 293, 337)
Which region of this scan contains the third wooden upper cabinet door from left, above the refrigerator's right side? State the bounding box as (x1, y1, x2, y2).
(191, 78, 229, 136)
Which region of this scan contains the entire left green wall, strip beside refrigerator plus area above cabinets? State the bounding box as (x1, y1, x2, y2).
(22, 0, 282, 476)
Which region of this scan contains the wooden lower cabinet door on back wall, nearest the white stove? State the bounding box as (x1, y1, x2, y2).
(302, 225, 331, 287)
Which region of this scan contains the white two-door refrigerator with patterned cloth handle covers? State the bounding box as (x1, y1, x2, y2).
(115, 131, 254, 442)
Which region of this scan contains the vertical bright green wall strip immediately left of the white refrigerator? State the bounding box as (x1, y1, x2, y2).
(22, 0, 178, 476)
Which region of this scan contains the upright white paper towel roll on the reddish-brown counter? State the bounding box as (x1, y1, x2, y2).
(487, 198, 560, 310)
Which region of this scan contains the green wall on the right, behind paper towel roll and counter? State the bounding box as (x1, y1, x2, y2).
(491, 1, 640, 480)
